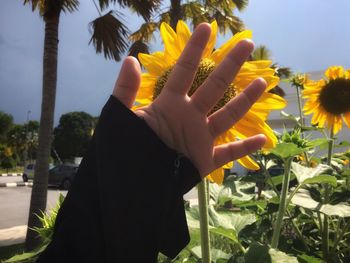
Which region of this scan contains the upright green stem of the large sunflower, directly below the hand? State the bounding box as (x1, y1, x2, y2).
(197, 179, 211, 263)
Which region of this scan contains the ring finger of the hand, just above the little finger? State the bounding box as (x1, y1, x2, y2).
(208, 78, 266, 138)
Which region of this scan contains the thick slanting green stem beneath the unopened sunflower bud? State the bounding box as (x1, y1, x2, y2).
(271, 158, 292, 248)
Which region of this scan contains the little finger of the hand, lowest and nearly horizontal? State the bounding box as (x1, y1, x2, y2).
(214, 134, 266, 169)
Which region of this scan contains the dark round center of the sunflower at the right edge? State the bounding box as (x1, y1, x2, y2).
(319, 78, 350, 115)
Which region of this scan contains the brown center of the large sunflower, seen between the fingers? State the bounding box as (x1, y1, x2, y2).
(153, 58, 236, 114)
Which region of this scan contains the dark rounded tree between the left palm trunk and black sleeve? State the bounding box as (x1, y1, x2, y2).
(53, 112, 95, 159)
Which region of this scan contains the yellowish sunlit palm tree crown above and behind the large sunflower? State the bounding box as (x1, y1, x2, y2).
(129, 0, 248, 57)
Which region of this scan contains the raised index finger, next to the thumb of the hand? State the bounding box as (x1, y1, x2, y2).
(165, 23, 211, 95)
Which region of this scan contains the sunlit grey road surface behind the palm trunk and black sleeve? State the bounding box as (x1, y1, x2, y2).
(0, 176, 197, 229)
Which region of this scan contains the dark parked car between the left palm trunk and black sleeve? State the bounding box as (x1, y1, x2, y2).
(49, 164, 79, 190)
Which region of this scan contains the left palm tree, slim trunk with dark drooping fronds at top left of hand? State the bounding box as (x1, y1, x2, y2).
(24, 0, 160, 250)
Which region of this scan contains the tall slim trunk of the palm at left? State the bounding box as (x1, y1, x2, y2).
(26, 13, 59, 250)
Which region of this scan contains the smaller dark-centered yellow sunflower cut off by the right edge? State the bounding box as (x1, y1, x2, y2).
(303, 66, 350, 134)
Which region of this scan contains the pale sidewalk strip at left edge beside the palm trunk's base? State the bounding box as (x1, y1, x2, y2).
(0, 225, 27, 247)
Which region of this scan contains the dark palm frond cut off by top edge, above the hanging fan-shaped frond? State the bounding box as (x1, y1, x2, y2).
(99, 0, 161, 21)
